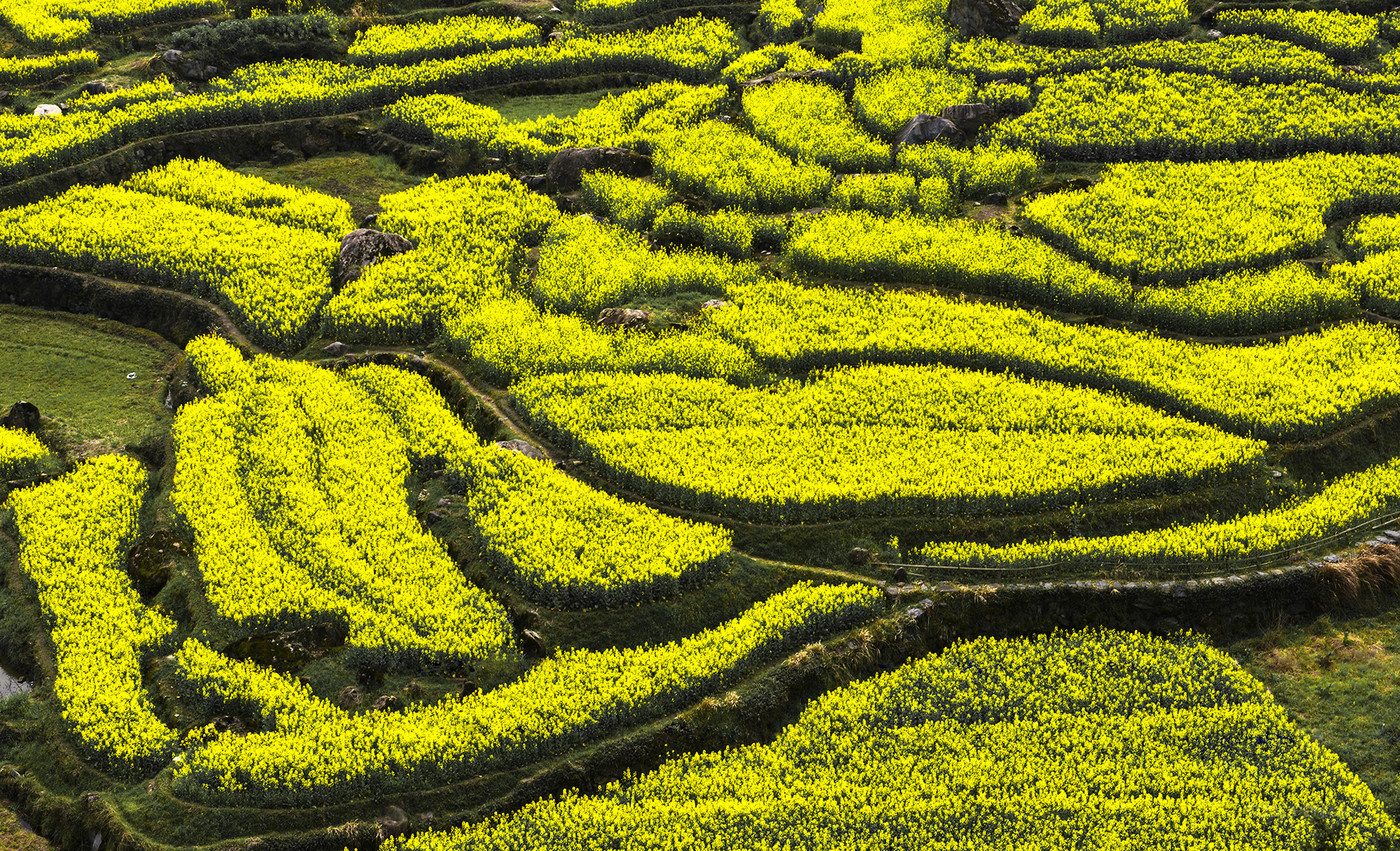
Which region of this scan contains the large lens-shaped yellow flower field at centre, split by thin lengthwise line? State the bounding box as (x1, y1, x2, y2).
(514, 367, 1264, 522)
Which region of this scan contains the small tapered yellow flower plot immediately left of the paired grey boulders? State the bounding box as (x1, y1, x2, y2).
(742, 80, 890, 172)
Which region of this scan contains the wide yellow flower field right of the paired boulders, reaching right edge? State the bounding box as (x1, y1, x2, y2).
(990, 67, 1400, 161)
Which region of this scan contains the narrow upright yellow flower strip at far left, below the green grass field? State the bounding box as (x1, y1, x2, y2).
(8, 455, 175, 770)
